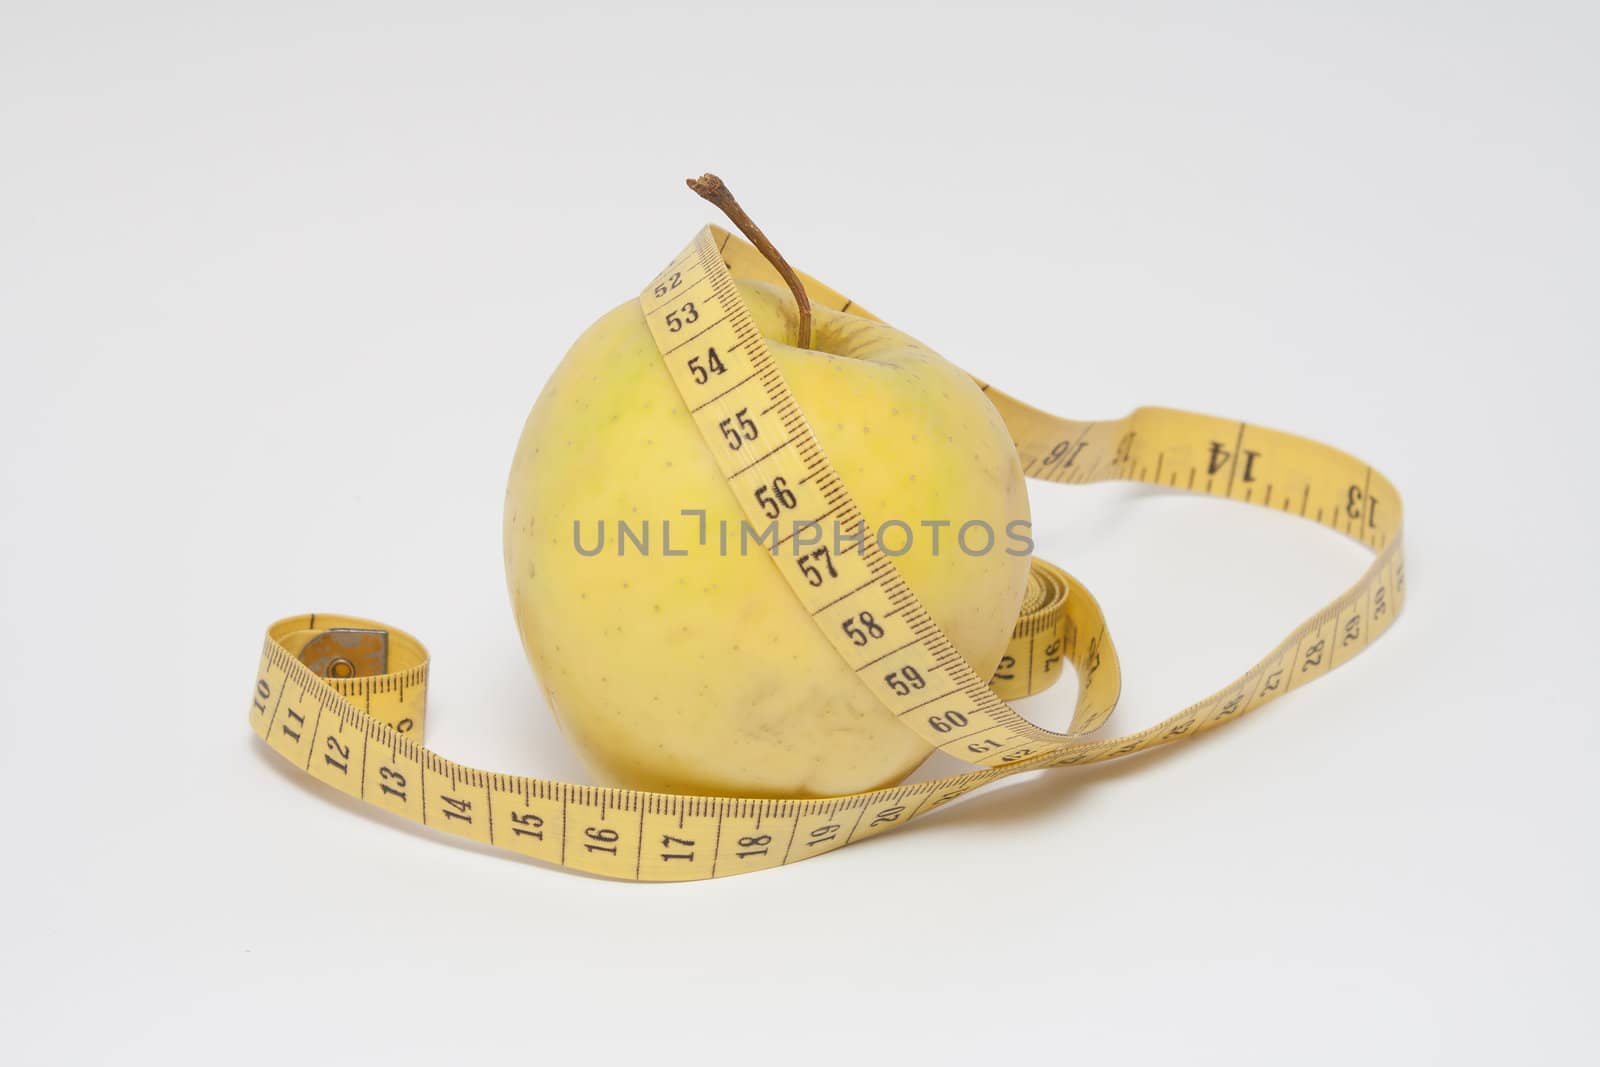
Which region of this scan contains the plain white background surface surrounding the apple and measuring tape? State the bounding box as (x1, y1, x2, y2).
(0, 2, 1600, 1064)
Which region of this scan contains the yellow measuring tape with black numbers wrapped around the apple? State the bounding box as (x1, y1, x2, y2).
(250, 220, 1405, 881)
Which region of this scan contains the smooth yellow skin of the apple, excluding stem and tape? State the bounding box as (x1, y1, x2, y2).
(504, 282, 1029, 797)
